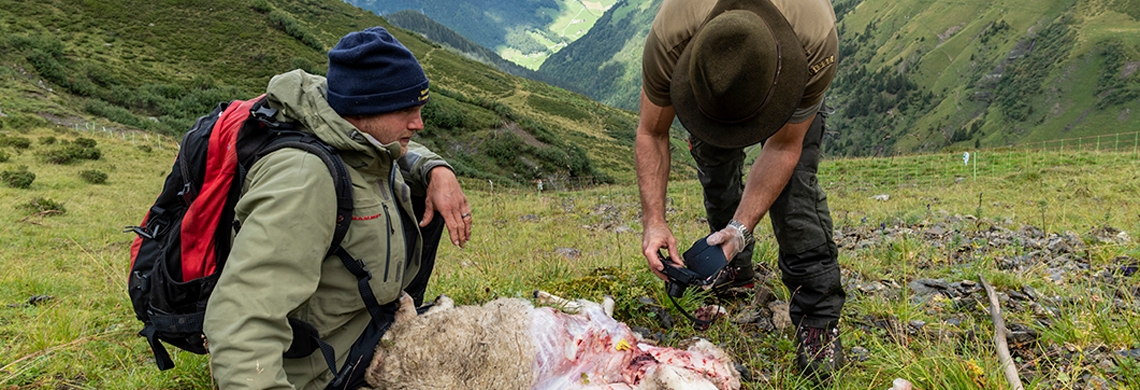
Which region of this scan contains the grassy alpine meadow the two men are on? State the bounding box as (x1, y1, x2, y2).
(0, 122, 1140, 389)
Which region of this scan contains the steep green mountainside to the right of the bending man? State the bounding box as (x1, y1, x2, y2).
(793, 0, 1140, 155)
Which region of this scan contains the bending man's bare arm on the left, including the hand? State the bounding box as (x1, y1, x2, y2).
(634, 90, 681, 279)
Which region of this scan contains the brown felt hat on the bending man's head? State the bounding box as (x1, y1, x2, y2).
(669, 0, 807, 147)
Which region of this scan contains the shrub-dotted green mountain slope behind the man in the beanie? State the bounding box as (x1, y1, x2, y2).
(0, 0, 686, 182)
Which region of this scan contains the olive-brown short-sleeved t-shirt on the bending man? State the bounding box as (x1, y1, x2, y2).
(642, 0, 839, 123)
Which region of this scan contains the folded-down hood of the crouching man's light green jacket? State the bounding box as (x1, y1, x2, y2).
(266, 70, 400, 160)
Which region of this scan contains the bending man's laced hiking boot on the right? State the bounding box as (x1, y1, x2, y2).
(796, 325, 845, 382)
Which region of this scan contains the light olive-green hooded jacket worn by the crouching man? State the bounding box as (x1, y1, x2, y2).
(203, 71, 449, 390)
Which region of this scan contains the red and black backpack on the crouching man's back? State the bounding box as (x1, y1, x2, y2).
(127, 96, 389, 387)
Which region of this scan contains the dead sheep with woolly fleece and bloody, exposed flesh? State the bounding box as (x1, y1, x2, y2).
(365, 290, 740, 390)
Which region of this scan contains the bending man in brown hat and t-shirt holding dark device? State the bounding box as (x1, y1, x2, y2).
(635, 0, 846, 379)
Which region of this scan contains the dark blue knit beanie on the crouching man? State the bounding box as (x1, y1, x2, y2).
(327, 27, 428, 116)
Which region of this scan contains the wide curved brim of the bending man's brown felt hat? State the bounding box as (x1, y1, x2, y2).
(669, 0, 808, 147)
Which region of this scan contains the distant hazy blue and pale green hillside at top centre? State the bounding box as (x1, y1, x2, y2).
(344, 0, 614, 70)
